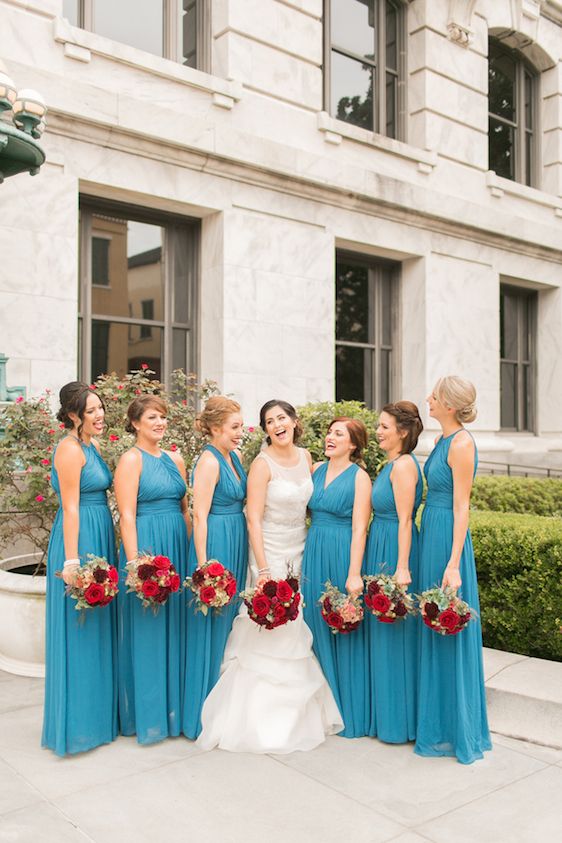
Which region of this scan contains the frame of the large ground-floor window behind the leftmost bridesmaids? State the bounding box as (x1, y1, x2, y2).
(77, 195, 201, 383)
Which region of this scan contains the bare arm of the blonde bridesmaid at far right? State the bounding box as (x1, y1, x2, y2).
(442, 432, 474, 589)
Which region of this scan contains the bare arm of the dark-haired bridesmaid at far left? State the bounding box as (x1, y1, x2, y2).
(55, 436, 86, 585)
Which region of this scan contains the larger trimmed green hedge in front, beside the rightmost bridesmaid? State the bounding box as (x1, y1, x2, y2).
(470, 512, 562, 661)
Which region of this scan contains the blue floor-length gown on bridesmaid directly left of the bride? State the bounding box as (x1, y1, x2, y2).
(183, 445, 248, 740)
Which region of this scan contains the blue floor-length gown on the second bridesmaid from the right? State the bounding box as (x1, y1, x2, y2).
(363, 454, 423, 743)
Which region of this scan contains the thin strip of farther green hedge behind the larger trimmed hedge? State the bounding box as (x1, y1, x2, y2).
(470, 477, 562, 516)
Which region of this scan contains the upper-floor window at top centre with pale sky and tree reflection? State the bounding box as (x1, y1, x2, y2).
(324, 0, 404, 138)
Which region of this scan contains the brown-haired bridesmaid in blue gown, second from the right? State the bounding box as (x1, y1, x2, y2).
(364, 401, 423, 743)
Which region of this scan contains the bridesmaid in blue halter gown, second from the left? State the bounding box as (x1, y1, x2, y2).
(115, 395, 191, 744)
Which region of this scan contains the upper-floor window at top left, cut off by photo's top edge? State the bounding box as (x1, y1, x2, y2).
(63, 0, 210, 70)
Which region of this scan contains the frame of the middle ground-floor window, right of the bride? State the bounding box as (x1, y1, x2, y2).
(334, 249, 400, 410)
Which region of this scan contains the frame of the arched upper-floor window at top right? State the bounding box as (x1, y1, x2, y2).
(488, 36, 541, 187)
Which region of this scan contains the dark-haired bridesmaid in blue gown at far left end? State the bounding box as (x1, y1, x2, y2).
(41, 381, 117, 755)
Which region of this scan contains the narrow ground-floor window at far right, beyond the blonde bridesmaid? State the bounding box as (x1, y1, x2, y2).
(500, 284, 537, 430)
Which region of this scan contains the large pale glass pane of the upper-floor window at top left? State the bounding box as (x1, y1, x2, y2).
(93, 0, 164, 56)
